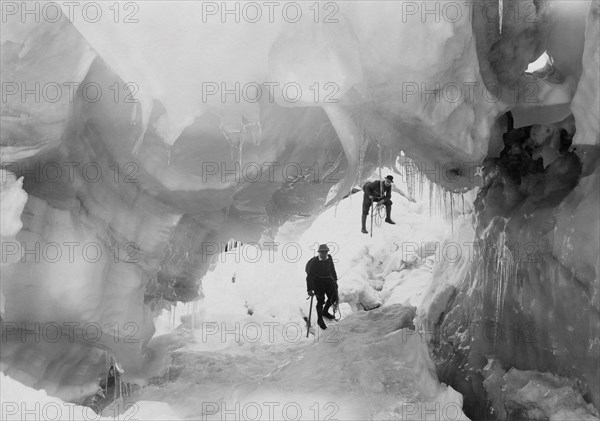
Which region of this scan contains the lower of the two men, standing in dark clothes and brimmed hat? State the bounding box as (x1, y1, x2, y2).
(306, 244, 338, 329)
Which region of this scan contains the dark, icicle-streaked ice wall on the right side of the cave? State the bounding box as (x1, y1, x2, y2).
(419, 2, 600, 416)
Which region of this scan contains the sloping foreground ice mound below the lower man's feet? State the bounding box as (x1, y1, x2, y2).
(148, 304, 472, 420)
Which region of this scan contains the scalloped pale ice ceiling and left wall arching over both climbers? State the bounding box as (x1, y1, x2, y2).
(1, 0, 600, 408)
